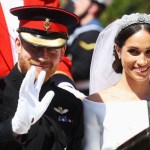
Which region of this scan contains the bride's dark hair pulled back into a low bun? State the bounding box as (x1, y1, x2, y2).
(112, 24, 150, 73)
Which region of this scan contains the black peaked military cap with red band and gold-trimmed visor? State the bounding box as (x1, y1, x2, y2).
(10, 0, 79, 48)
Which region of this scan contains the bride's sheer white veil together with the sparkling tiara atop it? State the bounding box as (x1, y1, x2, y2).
(89, 13, 150, 94)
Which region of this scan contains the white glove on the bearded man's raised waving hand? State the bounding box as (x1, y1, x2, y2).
(12, 66, 54, 134)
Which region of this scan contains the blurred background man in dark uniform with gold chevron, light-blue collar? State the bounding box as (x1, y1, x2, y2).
(67, 0, 106, 95)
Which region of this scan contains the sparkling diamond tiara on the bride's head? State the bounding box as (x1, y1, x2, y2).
(117, 13, 150, 35)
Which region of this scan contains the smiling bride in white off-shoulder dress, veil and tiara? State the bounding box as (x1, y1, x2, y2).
(83, 13, 150, 150)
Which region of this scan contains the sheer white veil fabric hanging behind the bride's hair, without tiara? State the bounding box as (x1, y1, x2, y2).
(90, 20, 121, 94)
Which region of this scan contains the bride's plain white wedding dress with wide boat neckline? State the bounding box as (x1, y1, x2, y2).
(83, 99, 149, 150)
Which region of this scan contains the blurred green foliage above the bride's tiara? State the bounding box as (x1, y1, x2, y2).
(100, 0, 150, 26)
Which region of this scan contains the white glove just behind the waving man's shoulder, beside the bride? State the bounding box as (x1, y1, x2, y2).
(58, 82, 86, 100)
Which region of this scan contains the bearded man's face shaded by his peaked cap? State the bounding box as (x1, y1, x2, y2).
(16, 38, 65, 80)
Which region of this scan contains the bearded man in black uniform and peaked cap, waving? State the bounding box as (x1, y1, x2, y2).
(0, 0, 83, 150)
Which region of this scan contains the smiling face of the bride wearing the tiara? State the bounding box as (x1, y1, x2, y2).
(117, 29, 150, 81)
